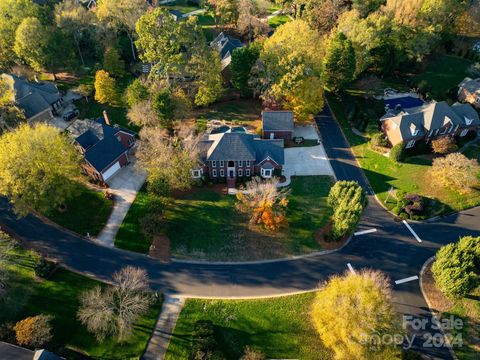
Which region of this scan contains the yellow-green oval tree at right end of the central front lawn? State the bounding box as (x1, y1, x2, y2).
(328, 181, 368, 240)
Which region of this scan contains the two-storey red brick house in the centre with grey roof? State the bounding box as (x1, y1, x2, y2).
(196, 132, 284, 187)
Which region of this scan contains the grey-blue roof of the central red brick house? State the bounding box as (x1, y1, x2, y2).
(201, 133, 285, 165)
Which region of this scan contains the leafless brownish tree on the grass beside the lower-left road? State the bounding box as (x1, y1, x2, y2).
(77, 266, 152, 341)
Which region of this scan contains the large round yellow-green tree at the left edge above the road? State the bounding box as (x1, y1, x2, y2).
(0, 124, 79, 215)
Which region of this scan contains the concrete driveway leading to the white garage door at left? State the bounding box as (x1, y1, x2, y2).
(95, 164, 147, 247)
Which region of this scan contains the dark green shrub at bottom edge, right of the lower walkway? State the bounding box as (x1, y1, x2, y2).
(190, 320, 225, 360)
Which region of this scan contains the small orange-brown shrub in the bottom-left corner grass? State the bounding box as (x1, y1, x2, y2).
(13, 314, 53, 347)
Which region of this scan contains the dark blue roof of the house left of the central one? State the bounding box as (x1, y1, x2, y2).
(75, 118, 133, 172)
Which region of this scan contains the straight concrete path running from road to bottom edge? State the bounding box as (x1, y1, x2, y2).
(142, 295, 185, 360)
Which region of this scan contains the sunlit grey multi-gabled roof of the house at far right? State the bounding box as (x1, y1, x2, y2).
(380, 101, 480, 140)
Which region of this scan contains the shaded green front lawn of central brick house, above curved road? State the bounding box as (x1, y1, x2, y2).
(115, 176, 332, 260)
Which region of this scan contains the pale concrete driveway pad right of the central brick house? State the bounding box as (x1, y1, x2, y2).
(283, 144, 334, 178)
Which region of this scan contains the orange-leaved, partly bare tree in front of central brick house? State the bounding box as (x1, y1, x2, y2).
(237, 177, 290, 231)
